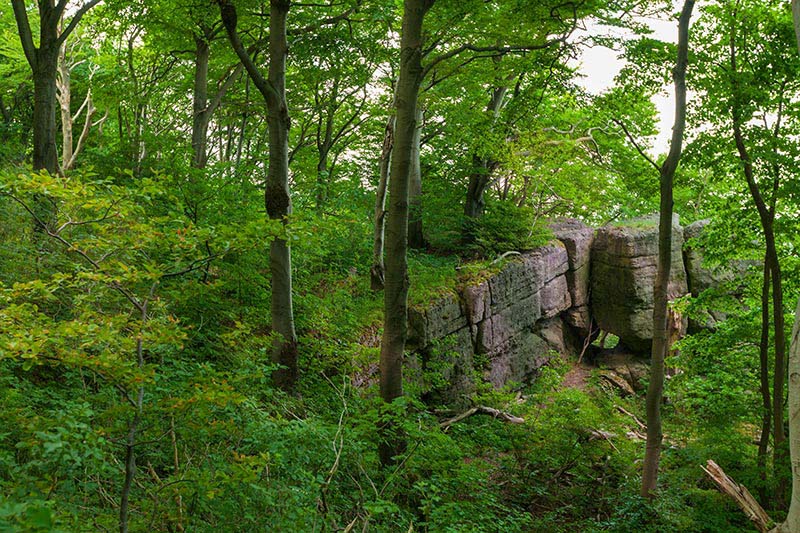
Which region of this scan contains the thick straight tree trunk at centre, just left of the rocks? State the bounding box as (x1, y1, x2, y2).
(379, 0, 433, 465)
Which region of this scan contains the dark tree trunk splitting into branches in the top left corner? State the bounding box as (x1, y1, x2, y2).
(11, 0, 100, 174)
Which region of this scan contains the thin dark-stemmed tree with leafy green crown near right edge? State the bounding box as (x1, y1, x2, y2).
(693, 1, 800, 500)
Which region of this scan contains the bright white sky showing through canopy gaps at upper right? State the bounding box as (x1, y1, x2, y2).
(578, 6, 697, 156)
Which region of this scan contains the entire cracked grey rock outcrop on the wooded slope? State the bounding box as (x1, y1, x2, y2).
(408, 212, 730, 404)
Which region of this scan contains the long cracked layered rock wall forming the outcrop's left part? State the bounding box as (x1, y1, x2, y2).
(409, 241, 572, 398)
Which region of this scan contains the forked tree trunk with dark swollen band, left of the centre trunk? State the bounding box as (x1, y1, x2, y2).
(219, 0, 298, 391)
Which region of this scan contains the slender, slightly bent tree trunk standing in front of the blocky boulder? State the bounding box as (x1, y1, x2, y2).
(642, 0, 694, 498)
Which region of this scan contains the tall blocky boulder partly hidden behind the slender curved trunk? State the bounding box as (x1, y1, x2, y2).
(591, 215, 688, 351)
